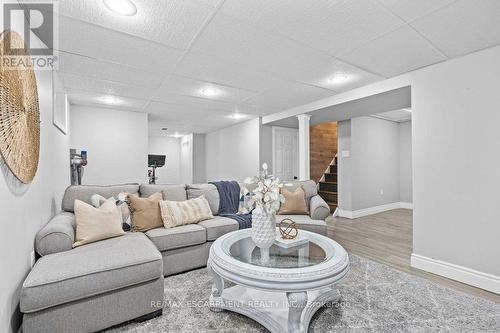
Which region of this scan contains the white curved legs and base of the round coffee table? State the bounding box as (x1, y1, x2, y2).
(208, 267, 340, 333)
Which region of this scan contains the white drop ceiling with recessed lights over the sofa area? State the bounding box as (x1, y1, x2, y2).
(59, 0, 500, 135)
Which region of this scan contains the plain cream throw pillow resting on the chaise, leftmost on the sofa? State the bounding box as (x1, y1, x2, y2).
(73, 199, 125, 247)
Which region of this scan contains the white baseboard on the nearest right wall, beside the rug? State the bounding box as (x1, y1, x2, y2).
(411, 253, 500, 294)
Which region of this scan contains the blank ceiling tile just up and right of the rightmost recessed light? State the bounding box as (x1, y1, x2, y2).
(340, 26, 446, 77)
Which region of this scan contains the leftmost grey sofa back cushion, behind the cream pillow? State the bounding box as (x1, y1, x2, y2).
(62, 184, 139, 213)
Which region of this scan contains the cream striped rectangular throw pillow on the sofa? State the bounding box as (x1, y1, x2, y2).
(160, 195, 214, 228)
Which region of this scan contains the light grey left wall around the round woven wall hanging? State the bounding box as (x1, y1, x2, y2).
(0, 9, 69, 333)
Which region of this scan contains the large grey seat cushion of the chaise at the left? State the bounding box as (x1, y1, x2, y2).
(20, 233, 163, 313)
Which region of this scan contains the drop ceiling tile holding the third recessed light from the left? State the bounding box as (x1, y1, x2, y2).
(156, 75, 255, 103)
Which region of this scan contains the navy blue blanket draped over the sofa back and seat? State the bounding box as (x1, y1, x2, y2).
(210, 180, 252, 229)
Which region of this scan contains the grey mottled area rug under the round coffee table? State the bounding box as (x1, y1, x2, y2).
(108, 254, 500, 333)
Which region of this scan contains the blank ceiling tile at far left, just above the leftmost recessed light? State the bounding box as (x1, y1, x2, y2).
(58, 72, 153, 100)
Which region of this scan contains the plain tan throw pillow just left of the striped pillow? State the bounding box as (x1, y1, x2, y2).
(127, 192, 163, 232)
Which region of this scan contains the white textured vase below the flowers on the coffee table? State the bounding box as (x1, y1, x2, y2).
(252, 207, 276, 249)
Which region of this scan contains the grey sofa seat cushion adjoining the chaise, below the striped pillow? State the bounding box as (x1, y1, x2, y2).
(146, 224, 207, 251)
